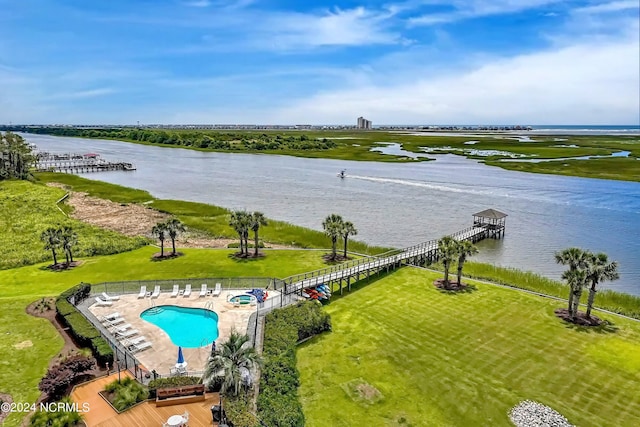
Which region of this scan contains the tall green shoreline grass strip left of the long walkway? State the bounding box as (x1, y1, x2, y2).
(36, 173, 390, 254)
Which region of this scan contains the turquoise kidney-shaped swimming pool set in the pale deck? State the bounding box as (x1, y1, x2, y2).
(140, 305, 218, 348)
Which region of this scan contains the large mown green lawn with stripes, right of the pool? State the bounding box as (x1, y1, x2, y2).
(297, 268, 640, 427)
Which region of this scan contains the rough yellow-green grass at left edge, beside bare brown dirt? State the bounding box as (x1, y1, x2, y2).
(0, 181, 147, 269)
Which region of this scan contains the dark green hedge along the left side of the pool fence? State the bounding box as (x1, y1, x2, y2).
(56, 283, 113, 366)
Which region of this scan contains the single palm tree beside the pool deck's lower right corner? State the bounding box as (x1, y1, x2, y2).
(203, 331, 260, 396)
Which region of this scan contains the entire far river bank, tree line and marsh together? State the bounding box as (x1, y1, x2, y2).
(22, 128, 640, 181)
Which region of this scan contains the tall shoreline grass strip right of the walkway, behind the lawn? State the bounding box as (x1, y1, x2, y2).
(456, 262, 640, 319)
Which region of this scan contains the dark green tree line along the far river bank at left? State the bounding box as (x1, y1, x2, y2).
(12, 127, 337, 151)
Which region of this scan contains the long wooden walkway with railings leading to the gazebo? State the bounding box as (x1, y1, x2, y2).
(276, 224, 504, 301)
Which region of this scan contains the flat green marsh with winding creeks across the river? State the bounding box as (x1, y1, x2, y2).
(30, 130, 640, 181)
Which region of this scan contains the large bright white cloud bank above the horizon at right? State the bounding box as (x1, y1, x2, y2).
(269, 38, 640, 124)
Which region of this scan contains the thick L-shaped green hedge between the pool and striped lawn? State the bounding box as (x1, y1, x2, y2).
(258, 301, 331, 427)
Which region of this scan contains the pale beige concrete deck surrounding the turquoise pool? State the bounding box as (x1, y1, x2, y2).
(89, 289, 278, 376)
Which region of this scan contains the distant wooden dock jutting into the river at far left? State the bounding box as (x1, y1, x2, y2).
(35, 153, 136, 173)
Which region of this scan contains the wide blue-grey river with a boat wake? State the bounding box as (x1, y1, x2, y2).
(23, 134, 640, 295)
